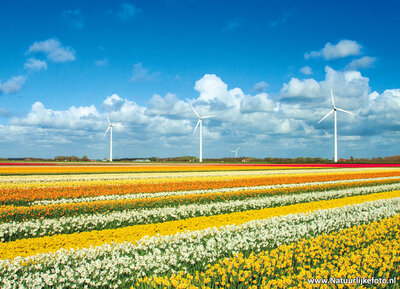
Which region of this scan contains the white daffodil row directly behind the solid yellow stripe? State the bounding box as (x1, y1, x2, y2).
(0, 183, 400, 242)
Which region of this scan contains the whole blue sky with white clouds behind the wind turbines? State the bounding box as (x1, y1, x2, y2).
(0, 0, 400, 158)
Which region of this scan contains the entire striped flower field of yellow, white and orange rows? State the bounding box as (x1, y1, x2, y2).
(0, 163, 400, 288)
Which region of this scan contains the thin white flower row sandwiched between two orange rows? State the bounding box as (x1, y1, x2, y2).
(31, 176, 400, 206)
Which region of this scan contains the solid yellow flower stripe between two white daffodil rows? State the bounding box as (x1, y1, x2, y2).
(0, 191, 400, 259)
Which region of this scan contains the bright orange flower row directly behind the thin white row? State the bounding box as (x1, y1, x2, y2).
(0, 171, 400, 206)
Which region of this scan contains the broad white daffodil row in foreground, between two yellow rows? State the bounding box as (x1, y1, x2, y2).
(0, 198, 400, 288)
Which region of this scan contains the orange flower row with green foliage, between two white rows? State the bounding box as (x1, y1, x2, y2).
(0, 179, 398, 223)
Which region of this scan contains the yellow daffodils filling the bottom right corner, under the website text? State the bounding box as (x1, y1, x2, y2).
(135, 215, 400, 288)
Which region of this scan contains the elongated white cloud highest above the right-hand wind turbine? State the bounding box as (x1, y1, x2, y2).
(304, 39, 361, 60)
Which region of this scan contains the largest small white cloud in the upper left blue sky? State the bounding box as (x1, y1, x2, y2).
(28, 38, 76, 62)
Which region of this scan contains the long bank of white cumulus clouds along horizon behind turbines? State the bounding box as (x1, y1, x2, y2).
(0, 71, 400, 158)
